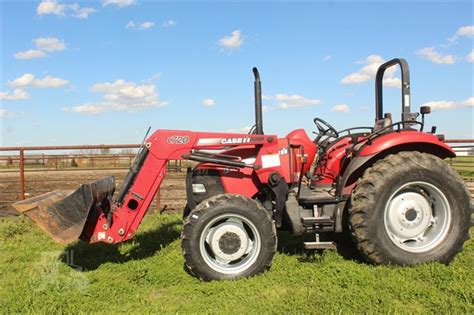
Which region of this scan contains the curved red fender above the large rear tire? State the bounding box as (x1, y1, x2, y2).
(338, 130, 456, 197)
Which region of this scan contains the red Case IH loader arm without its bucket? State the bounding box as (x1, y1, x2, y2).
(83, 130, 280, 243)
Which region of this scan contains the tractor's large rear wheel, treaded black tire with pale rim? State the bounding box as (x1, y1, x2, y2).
(349, 152, 471, 265)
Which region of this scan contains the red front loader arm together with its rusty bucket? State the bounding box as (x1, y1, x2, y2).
(14, 130, 282, 243)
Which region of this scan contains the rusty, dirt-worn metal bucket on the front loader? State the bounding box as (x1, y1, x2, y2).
(13, 177, 115, 244)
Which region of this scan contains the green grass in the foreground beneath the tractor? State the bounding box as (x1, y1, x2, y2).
(0, 214, 474, 314)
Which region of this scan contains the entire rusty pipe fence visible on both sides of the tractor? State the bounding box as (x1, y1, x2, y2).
(0, 139, 474, 217)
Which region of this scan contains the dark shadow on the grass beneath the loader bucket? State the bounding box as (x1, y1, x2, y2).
(61, 220, 181, 271)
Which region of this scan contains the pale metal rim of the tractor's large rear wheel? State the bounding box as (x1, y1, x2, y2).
(384, 182, 451, 253)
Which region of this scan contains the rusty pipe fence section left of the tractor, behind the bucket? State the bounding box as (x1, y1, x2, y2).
(0, 144, 184, 216)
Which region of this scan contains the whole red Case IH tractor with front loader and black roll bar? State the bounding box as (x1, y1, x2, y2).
(15, 59, 472, 280)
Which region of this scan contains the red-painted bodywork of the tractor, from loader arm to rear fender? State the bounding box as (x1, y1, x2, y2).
(85, 129, 454, 243)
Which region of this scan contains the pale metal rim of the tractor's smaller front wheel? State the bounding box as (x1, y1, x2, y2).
(199, 214, 261, 274)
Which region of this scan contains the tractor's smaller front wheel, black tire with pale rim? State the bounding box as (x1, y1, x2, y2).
(181, 194, 277, 281)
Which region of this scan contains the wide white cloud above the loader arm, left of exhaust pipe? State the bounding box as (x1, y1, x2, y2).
(63, 80, 168, 115)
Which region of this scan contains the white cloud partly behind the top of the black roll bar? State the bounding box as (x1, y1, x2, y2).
(341, 55, 400, 87)
